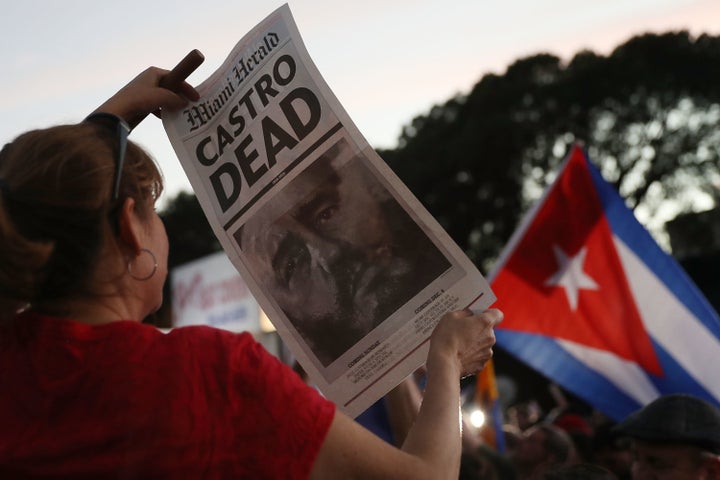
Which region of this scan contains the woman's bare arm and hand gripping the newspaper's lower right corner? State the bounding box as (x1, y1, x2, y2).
(310, 310, 502, 480)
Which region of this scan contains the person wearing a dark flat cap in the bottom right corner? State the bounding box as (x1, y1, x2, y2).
(615, 393, 720, 480)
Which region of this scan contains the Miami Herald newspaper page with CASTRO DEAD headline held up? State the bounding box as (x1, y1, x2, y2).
(163, 5, 495, 417)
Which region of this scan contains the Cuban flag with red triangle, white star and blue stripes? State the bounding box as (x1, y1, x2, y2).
(490, 147, 720, 420)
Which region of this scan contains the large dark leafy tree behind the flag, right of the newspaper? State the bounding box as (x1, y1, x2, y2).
(380, 32, 720, 268)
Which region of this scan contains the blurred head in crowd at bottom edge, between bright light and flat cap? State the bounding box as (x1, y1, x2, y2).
(510, 423, 575, 480)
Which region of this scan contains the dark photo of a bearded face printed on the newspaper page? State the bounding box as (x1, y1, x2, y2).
(236, 140, 450, 367)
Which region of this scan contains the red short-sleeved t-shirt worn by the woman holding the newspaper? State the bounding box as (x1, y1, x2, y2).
(0, 314, 335, 479)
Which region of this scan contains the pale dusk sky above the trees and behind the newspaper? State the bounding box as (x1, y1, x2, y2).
(0, 0, 720, 203)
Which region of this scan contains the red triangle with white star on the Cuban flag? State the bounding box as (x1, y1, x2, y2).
(492, 147, 662, 375)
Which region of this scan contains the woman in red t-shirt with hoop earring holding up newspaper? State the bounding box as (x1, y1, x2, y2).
(0, 56, 502, 480)
